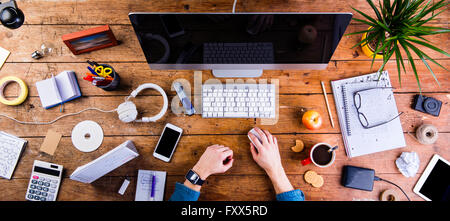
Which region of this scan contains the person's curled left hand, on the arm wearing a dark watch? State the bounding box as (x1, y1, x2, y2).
(192, 144, 234, 180)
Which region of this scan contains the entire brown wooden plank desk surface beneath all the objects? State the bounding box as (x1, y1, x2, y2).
(0, 0, 450, 201)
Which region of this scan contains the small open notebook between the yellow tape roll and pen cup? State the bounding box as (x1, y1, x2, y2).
(36, 71, 81, 109)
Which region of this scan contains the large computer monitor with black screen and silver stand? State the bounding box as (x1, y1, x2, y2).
(129, 12, 352, 77)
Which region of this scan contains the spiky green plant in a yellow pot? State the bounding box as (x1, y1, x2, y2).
(348, 0, 450, 91)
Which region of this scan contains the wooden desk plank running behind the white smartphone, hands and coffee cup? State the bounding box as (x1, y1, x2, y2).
(7, 132, 450, 179)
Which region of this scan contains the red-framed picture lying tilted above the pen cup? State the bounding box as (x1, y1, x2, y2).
(62, 25, 117, 55)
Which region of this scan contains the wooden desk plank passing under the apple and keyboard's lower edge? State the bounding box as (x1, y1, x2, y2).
(0, 93, 444, 136)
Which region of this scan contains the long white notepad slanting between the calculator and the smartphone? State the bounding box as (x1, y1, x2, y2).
(70, 140, 139, 183)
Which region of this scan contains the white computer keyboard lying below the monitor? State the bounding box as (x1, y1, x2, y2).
(202, 84, 276, 118)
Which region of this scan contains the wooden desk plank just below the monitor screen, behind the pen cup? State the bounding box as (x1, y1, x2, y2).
(0, 60, 450, 96)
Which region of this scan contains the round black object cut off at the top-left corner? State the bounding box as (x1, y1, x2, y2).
(0, 0, 25, 29)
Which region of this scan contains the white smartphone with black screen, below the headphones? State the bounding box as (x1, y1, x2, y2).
(153, 123, 183, 162)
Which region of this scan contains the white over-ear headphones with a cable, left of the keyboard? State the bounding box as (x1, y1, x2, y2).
(117, 83, 169, 123)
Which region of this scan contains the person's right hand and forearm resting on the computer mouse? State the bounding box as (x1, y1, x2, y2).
(248, 127, 294, 194)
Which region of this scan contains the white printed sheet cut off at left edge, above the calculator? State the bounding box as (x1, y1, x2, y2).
(0, 131, 27, 179)
